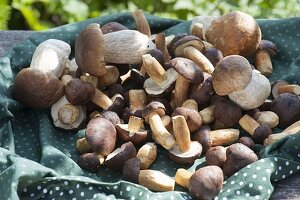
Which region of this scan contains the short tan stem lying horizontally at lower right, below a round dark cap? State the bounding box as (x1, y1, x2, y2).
(210, 128, 240, 146)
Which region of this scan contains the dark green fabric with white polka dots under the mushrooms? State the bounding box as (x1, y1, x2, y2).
(0, 13, 300, 200)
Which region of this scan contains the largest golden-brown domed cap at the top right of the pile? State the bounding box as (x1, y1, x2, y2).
(205, 11, 261, 56)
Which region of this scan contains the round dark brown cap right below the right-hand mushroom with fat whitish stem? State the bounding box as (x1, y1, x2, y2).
(214, 99, 242, 127)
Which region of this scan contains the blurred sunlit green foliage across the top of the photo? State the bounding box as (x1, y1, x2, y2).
(0, 0, 300, 30)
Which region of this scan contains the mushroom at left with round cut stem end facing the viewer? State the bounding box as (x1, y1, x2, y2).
(51, 96, 86, 130)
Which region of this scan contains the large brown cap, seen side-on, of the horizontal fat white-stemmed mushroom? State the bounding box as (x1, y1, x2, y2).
(75, 23, 106, 76)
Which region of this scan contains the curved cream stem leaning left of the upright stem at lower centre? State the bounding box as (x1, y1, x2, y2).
(149, 112, 175, 150)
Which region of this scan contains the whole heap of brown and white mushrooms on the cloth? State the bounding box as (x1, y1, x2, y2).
(13, 10, 300, 199)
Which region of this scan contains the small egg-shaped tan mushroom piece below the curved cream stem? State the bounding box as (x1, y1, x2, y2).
(136, 142, 157, 169)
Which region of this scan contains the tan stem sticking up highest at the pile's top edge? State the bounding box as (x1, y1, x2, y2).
(132, 10, 151, 37)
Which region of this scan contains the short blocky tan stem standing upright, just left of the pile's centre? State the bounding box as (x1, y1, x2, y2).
(128, 90, 147, 110)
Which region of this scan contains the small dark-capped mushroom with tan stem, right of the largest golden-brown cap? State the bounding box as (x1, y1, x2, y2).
(255, 40, 278, 76)
